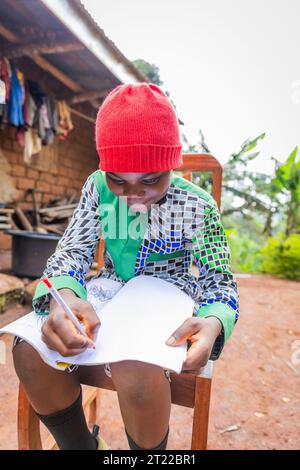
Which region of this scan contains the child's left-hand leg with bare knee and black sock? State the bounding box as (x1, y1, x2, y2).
(13, 341, 98, 450)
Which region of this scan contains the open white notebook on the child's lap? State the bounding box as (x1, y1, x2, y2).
(0, 276, 194, 373)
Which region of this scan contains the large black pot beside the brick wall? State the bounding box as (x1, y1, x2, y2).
(6, 230, 61, 277)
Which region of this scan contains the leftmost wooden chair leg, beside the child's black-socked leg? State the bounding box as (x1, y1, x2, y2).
(18, 383, 42, 450)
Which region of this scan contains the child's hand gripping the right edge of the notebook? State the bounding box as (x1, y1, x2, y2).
(166, 317, 222, 374)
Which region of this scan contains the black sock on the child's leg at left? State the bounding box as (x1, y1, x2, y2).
(36, 388, 98, 450)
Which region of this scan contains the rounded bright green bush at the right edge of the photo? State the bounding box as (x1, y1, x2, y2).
(261, 234, 300, 281)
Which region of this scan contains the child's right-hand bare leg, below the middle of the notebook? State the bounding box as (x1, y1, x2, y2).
(111, 361, 171, 449)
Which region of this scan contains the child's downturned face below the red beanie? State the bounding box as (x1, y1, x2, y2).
(106, 170, 172, 209)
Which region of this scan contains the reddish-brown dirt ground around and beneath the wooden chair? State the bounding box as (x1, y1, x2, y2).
(0, 276, 300, 450)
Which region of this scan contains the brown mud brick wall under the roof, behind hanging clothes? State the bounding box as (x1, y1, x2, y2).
(0, 115, 99, 249)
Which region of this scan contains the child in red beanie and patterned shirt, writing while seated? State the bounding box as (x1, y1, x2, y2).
(13, 83, 238, 449)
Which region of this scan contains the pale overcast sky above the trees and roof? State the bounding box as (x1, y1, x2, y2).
(83, 0, 300, 173)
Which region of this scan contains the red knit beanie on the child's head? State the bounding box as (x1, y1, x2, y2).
(96, 83, 182, 173)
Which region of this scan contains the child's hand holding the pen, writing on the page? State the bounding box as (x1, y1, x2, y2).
(42, 289, 100, 356)
